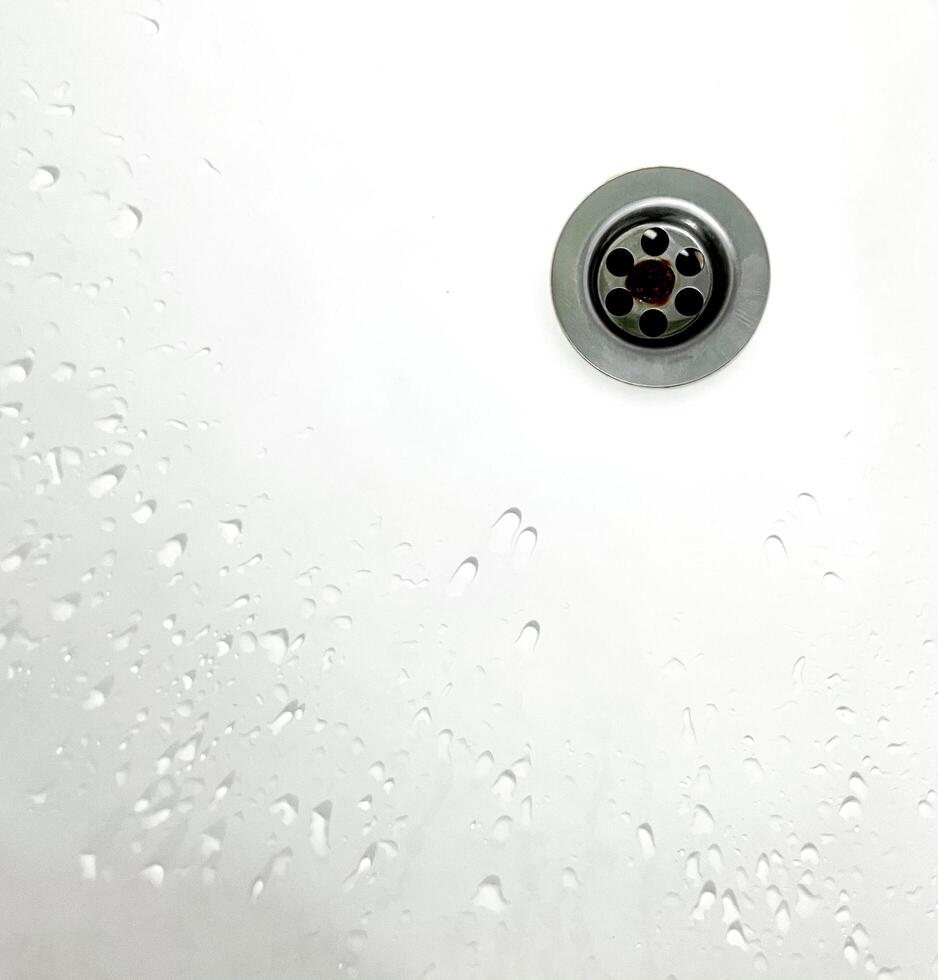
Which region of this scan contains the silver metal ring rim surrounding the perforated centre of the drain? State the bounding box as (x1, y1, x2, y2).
(551, 167, 770, 387)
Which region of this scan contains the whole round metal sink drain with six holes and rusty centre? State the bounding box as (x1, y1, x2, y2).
(551, 167, 769, 387)
